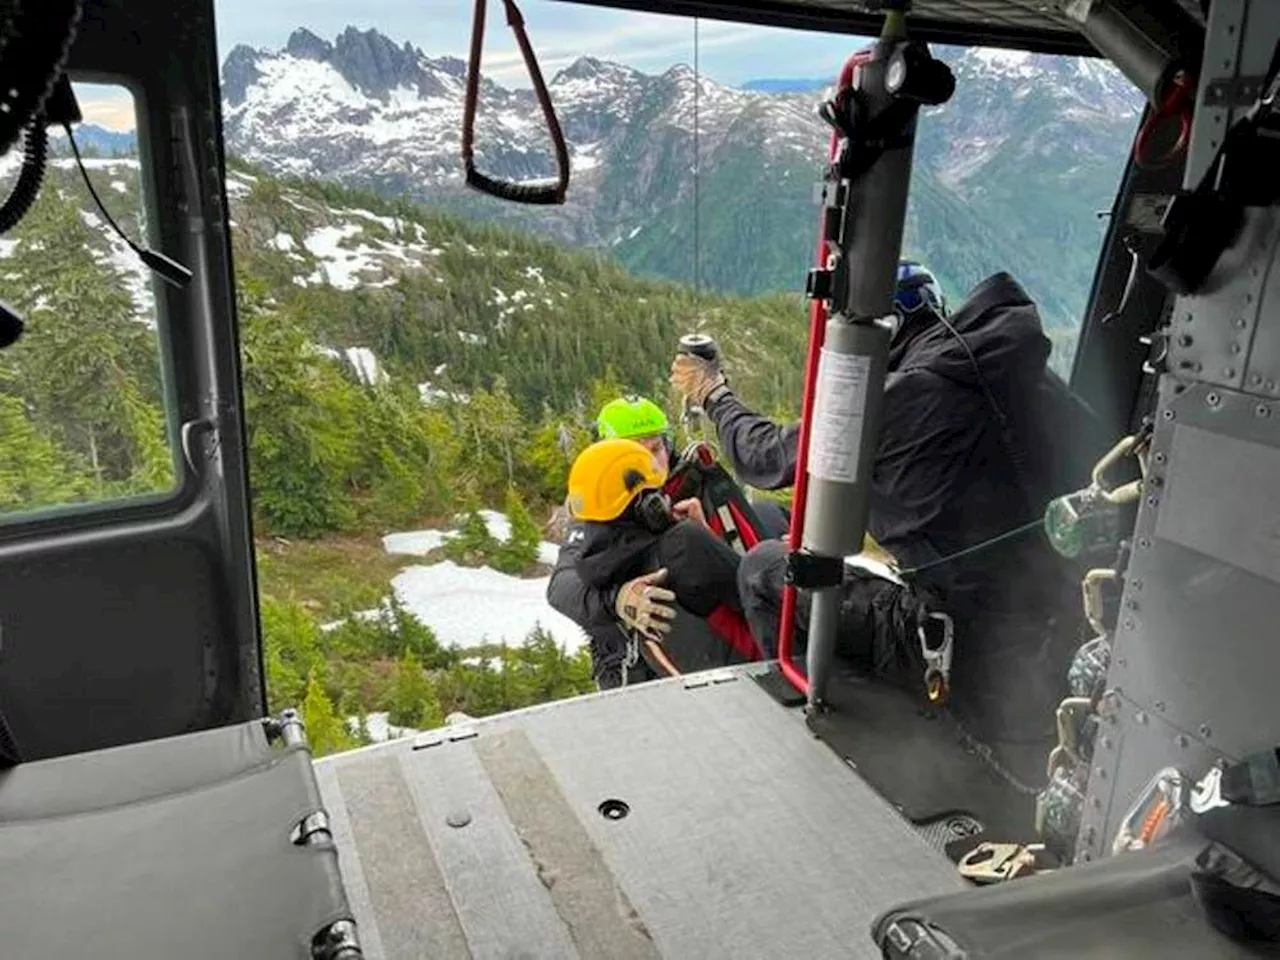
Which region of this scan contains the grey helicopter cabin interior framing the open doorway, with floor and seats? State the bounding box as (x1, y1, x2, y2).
(0, 0, 1280, 960)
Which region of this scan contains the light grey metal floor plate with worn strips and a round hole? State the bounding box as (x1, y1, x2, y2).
(316, 672, 963, 960)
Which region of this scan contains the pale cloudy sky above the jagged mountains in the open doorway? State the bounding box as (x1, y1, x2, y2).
(215, 0, 875, 86)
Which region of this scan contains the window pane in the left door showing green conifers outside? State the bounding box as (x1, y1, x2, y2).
(0, 83, 177, 520)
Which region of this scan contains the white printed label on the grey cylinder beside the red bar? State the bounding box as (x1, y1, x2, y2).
(809, 348, 872, 484)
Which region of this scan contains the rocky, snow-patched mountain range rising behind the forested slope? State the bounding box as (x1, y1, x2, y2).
(223, 28, 1140, 323)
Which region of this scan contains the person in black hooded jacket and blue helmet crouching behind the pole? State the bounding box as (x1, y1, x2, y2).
(671, 264, 1108, 740)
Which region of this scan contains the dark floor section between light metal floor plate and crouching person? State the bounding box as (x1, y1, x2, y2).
(808, 672, 1050, 841)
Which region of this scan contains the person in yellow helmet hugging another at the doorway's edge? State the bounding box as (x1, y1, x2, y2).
(548, 440, 759, 687)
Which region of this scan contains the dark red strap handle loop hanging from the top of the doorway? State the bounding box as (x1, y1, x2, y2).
(462, 0, 568, 204)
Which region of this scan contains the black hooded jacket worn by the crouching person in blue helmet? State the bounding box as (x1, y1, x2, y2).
(707, 273, 1107, 616)
